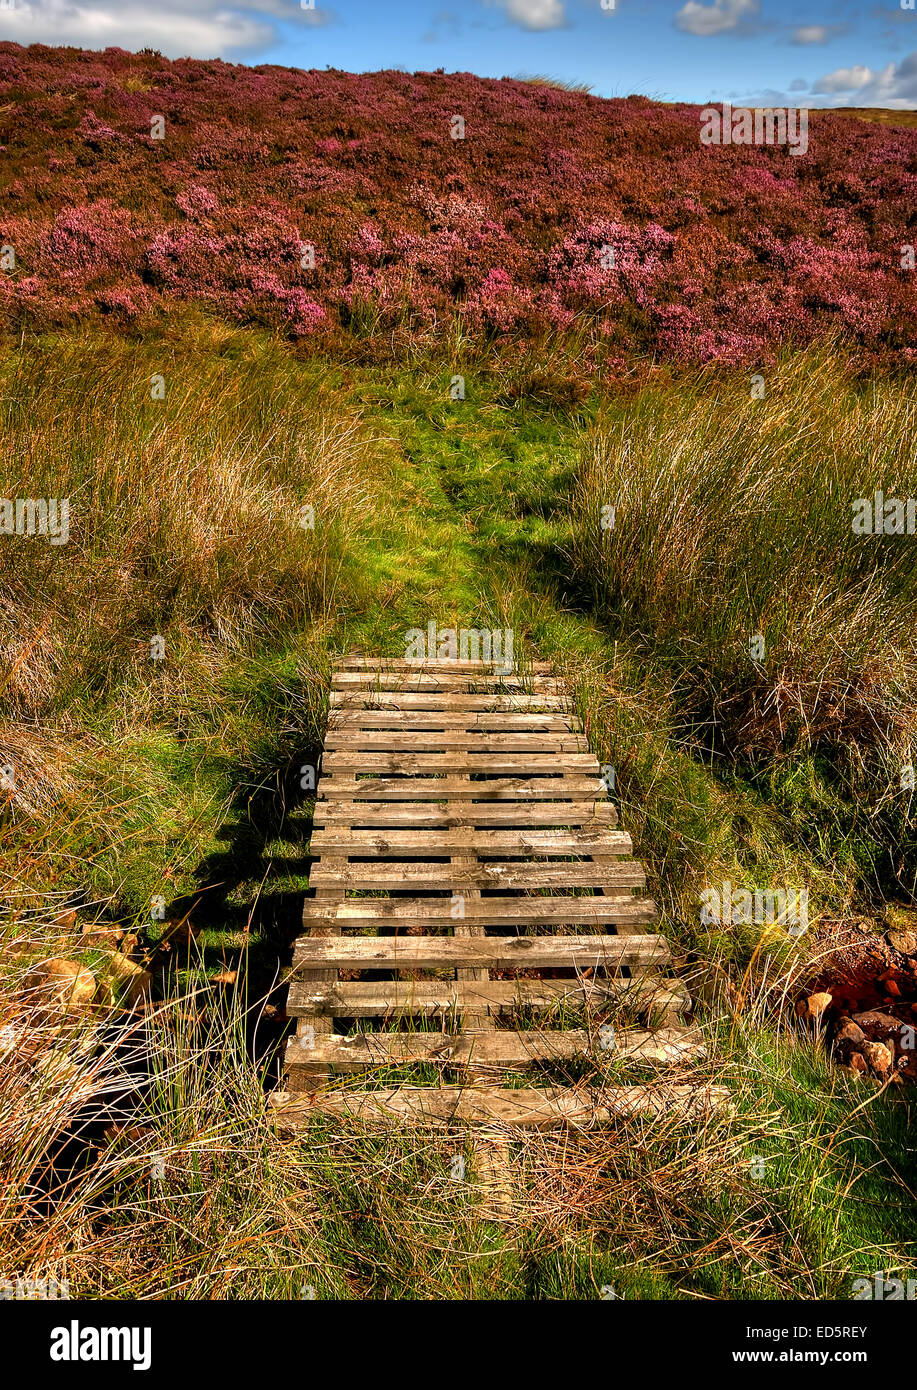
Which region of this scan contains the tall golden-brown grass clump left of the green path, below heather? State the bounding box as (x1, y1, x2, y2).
(0, 325, 371, 717)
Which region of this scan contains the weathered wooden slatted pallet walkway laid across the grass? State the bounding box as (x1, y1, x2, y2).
(275, 657, 720, 1127)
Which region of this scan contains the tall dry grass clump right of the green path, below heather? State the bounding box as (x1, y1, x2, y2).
(574, 353, 917, 765)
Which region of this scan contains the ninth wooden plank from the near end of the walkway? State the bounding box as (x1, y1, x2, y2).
(318, 765, 604, 802)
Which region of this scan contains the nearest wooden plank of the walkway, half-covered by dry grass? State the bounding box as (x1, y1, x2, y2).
(271, 1081, 729, 1131)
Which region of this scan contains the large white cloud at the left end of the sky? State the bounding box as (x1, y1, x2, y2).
(0, 0, 328, 58)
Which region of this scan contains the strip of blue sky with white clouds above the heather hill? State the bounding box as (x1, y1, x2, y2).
(0, 0, 917, 108)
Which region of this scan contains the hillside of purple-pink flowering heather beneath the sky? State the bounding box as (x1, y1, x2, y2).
(0, 43, 917, 361)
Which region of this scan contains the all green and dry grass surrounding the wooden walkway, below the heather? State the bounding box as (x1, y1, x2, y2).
(0, 318, 917, 1298)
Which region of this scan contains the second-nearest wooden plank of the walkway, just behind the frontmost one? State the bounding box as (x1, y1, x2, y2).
(286, 1029, 704, 1072)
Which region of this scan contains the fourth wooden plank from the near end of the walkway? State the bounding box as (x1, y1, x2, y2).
(293, 934, 668, 972)
